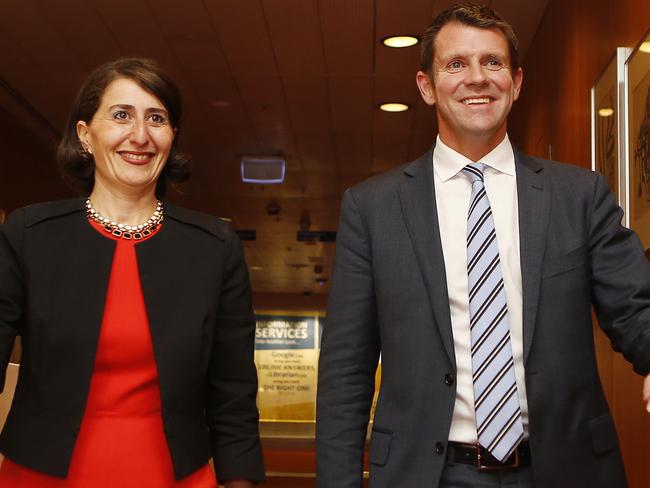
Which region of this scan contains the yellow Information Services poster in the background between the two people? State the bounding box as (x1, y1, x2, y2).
(255, 311, 324, 422)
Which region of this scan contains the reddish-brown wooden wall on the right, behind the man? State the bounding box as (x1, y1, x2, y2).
(510, 0, 650, 488)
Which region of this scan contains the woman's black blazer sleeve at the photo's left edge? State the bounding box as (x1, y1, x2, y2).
(0, 209, 25, 390)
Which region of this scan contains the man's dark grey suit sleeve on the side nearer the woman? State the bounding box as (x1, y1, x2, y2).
(316, 190, 380, 488)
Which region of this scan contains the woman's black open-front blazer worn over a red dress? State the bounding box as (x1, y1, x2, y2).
(0, 199, 264, 480)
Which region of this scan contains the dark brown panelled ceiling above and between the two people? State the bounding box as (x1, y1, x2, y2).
(0, 0, 546, 293)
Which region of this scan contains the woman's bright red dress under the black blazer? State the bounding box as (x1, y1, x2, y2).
(0, 222, 217, 488)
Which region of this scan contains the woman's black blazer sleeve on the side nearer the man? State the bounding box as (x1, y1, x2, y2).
(206, 229, 264, 481)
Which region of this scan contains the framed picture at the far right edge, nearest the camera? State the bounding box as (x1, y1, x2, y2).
(625, 31, 650, 249)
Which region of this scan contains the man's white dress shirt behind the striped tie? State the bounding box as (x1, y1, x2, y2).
(433, 135, 528, 444)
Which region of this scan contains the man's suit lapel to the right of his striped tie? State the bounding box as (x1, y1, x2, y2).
(515, 150, 551, 363)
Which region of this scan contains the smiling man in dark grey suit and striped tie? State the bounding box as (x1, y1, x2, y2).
(317, 5, 650, 488)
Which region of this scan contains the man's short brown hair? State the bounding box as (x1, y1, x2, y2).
(420, 3, 519, 73)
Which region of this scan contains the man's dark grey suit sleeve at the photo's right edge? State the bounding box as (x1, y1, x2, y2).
(589, 175, 650, 375)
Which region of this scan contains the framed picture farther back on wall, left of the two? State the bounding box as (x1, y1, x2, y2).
(591, 47, 632, 207)
